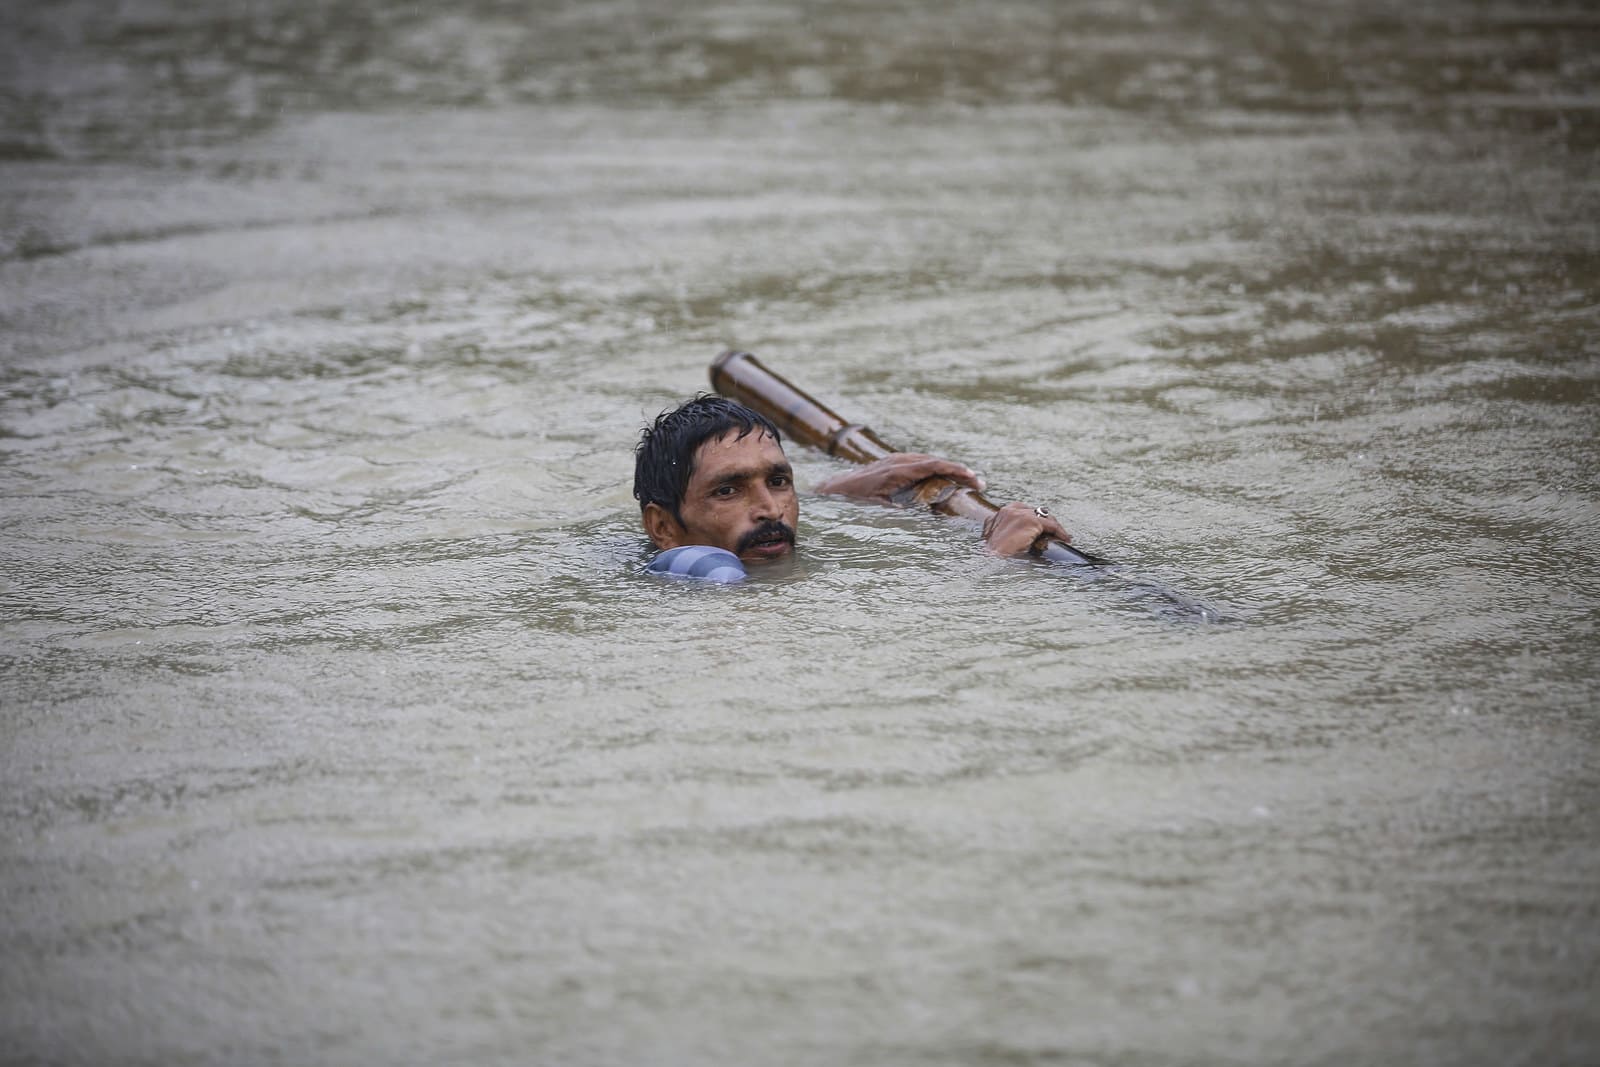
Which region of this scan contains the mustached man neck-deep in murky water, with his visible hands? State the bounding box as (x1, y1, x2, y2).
(634, 395, 1070, 581)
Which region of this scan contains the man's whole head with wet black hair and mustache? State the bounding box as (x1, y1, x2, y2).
(634, 397, 800, 561)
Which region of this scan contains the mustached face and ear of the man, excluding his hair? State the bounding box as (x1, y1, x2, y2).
(645, 430, 800, 563)
